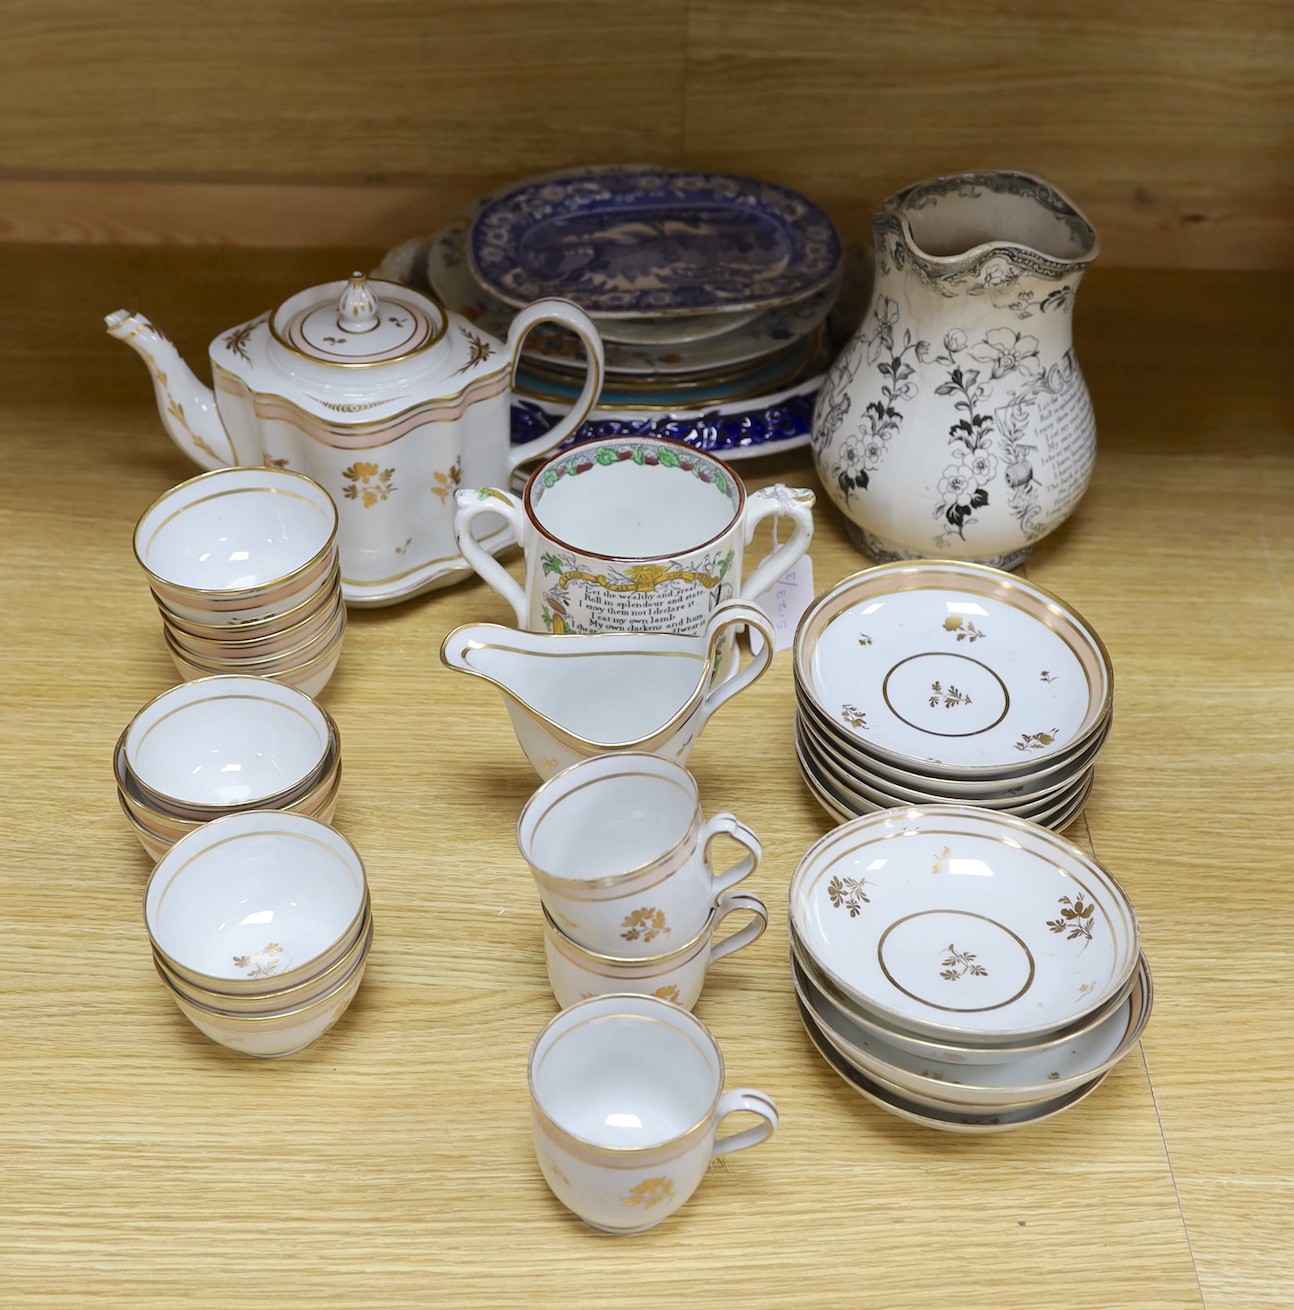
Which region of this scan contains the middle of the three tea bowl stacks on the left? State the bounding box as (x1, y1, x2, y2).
(113, 673, 342, 861)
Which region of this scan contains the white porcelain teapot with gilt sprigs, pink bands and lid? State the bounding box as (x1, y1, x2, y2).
(105, 272, 604, 605)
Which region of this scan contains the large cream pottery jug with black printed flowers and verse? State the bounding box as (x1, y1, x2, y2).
(812, 172, 1098, 569)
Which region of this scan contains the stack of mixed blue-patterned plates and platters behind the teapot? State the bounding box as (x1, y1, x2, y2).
(379, 168, 859, 459)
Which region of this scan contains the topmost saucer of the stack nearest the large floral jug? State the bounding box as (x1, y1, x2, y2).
(794, 561, 1113, 779)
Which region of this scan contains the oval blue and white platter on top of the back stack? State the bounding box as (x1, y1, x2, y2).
(468, 170, 842, 318)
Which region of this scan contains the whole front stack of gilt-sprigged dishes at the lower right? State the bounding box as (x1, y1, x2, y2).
(790, 806, 1153, 1133)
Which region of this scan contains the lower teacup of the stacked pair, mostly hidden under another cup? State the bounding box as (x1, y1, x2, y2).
(544, 892, 769, 1010)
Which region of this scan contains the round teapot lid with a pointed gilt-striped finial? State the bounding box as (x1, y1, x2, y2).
(270, 272, 447, 367)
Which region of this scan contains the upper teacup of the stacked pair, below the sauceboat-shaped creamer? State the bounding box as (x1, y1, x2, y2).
(517, 752, 762, 958)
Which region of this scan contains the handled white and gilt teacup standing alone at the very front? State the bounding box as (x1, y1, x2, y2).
(529, 996, 778, 1234)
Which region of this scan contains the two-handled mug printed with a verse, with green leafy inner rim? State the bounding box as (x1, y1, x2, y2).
(454, 436, 813, 634)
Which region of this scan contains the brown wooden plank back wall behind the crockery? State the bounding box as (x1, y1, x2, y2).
(0, 0, 1294, 269)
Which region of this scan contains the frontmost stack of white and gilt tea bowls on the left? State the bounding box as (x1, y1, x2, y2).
(144, 810, 373, 1058)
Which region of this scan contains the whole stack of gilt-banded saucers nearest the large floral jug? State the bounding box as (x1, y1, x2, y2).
(795, 561, 1113, 829)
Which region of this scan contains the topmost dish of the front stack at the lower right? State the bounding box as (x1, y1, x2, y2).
(788, 806, 1139, 1047)
